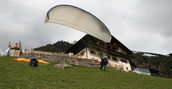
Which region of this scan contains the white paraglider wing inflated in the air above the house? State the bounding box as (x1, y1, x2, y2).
(45, 5, 111, 42)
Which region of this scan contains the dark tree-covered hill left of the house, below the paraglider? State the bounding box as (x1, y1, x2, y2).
(34, 41, 73, 52)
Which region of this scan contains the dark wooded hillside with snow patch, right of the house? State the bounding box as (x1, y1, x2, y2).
(130, 52, 172, 78)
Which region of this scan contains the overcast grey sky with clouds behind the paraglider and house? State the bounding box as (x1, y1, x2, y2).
(0, 0, 172, 54)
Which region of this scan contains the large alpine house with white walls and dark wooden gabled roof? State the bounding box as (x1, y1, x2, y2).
(66, 35, 132, 71)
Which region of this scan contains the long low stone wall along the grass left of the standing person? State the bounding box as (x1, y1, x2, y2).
(21, 53, 100, 67)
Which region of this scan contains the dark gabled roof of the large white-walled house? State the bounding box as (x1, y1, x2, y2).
(66, 34, 132, 55)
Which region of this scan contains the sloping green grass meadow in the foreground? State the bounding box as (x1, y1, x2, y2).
(0, 57, 172, 89)
